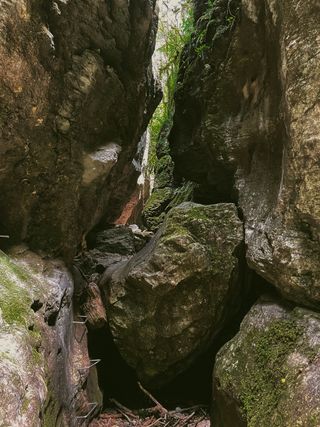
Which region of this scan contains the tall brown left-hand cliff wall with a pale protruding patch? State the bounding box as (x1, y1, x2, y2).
(0, 0, 156, 260)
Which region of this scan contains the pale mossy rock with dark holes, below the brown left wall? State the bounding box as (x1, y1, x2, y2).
(0, 247, 101, 427)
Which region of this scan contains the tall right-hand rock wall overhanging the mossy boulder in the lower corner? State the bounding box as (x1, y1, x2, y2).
(170, 0, 320, 307)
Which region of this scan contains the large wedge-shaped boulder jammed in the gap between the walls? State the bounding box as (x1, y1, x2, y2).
(104, 203, 243, 386)
